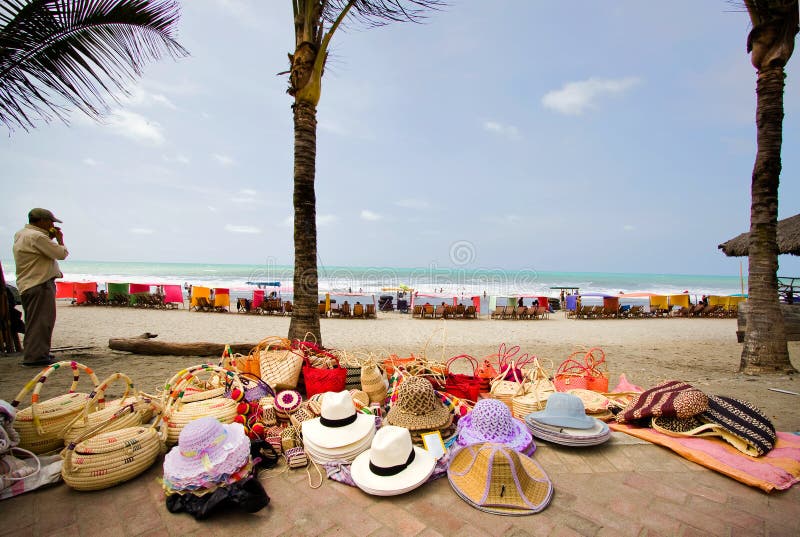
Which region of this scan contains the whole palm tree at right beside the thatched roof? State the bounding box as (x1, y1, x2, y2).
(739, 0, 798, 374)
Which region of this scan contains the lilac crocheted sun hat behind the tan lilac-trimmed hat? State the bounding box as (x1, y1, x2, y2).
(456, 399, 536, 453)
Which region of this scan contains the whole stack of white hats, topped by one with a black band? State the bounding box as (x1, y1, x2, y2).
(302, 391, 375, 464)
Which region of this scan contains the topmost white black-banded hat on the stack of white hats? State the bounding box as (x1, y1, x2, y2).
(303, 391, 375, 449)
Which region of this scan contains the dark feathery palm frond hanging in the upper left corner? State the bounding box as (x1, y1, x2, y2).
(0, 0, 188, 130)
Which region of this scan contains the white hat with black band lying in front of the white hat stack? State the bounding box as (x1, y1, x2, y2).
(350, 425, 436, 496)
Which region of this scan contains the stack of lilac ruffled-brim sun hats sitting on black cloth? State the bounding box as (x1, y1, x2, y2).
(163, 416, 252, 495)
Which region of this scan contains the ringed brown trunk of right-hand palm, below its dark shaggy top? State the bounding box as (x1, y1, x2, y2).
(739, 66, 794, 374)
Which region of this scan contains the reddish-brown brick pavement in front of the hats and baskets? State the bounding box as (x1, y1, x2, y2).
(0, 433, 800, 537)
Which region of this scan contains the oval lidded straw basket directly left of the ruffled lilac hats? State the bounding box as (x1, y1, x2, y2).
(61, 405, 165, 491)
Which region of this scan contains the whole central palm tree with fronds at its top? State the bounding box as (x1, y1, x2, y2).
(288, 0, 446, 344)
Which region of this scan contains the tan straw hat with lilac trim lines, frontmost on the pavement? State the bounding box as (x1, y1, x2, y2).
(447, 443, 553, 515)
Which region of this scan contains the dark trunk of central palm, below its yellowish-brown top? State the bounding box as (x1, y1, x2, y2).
(289, 100, 322, 345)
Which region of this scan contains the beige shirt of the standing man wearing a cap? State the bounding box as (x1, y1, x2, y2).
(13, 224, 69, 293)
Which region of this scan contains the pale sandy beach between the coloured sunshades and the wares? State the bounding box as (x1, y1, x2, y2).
(0, 301, 800, 431)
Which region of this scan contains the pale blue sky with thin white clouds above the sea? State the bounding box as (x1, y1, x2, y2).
(0, 0, 800, 276)
